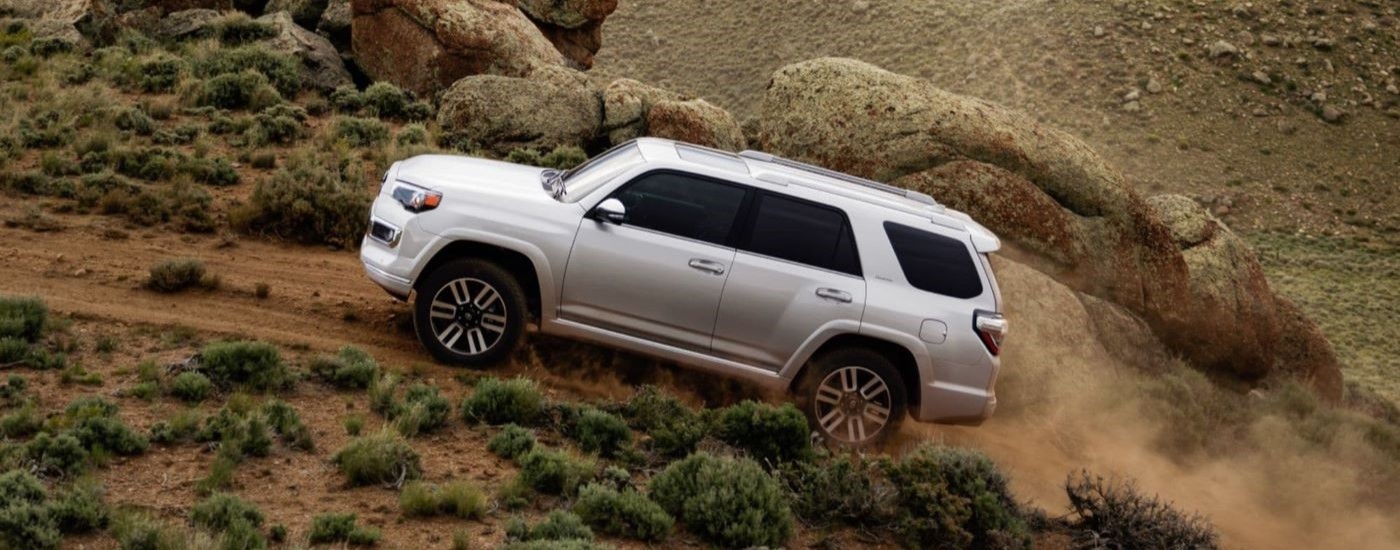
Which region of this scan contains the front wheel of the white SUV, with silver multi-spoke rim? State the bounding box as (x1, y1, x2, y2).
(413, 259, 528, 367)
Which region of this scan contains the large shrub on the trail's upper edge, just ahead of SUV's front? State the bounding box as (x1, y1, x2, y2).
(230, 149, 372, 248)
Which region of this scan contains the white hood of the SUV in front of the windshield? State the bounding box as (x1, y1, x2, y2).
(391, 155, 553, 200)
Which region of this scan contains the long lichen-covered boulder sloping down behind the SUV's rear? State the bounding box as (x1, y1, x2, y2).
(760, 59, 1341, 397)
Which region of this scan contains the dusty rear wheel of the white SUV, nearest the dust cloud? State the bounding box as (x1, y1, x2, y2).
(797, 347, 909, 448)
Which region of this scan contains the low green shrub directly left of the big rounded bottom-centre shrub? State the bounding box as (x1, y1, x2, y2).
(573, 484, 675, 542)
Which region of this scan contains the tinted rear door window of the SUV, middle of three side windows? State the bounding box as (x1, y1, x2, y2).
(743, 193, 861, 277)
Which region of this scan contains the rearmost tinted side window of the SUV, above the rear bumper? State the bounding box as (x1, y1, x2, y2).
(885, 221, 981, 298)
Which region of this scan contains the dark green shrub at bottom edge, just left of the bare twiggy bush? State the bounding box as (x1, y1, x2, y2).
(886, 444, 1030, 549)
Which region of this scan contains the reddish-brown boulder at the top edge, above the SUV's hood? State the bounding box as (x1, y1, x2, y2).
(351, 0, 566, 95)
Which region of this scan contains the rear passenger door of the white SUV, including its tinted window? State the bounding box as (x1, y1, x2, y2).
(713, 192, 865, 371)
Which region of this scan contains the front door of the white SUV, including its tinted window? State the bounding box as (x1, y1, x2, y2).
(560, 171, 749, 351)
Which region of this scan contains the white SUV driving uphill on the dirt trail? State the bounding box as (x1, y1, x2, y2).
(360, 139, 1007, 445)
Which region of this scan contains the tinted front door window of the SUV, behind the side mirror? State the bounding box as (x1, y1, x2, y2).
(613, 172, 748, 245)
